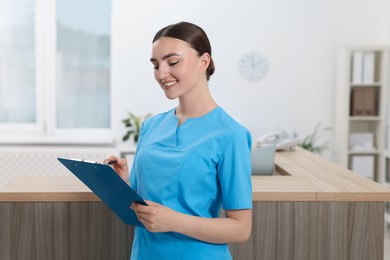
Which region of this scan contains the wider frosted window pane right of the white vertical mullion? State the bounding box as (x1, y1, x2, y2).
(57, 0, 110, 128)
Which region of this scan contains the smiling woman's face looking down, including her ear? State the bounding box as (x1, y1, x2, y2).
(150, 37, 210, 99)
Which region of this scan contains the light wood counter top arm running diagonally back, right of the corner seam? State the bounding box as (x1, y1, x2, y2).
(275, 147, 390, 201)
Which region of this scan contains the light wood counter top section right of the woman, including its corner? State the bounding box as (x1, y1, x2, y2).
(252, 147, 390, 201)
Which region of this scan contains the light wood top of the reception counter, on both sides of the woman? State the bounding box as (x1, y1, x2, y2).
(0, 148, 390, 202)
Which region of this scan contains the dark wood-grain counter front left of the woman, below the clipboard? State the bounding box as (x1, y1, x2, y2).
(0, 202, 133, 260)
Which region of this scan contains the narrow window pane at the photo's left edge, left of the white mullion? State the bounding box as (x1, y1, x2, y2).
(0, 0, 37, 124)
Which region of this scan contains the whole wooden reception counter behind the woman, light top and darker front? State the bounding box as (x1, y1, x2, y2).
(0, 148, 390, 260)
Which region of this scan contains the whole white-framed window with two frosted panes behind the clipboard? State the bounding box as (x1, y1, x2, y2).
(0, 0, 112, 143)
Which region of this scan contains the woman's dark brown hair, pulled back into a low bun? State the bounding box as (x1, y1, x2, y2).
(153, 22, 215, 80)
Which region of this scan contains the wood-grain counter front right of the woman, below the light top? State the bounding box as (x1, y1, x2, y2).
(230, 202, 384, 260)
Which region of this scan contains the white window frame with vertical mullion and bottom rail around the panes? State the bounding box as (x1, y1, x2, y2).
(0, 0, 115, 145)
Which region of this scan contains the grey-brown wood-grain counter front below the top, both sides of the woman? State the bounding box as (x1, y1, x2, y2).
(0, 202, 384, 260)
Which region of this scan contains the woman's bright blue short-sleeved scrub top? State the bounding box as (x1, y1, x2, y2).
(130, 107, 252, 260)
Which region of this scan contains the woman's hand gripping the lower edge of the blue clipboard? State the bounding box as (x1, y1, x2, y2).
(131, 200, 178, 232)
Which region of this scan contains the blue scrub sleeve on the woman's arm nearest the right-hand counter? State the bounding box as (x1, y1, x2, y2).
(218, 129, 252, 210)
